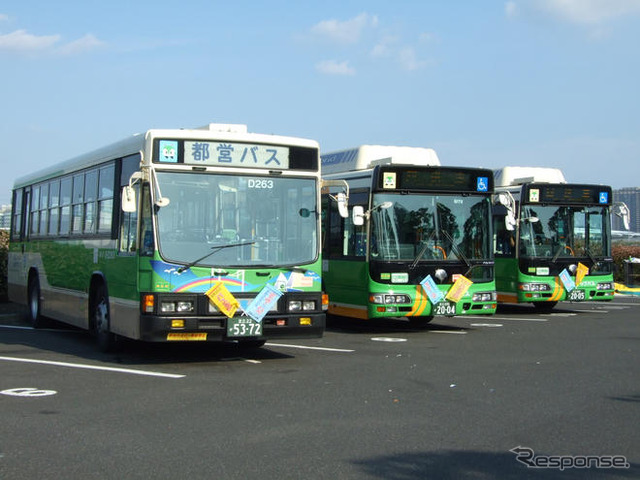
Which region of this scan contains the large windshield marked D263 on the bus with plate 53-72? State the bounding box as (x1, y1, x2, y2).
(157, 172, 318, 267)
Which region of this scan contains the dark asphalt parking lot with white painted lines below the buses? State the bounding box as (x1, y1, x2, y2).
(0, 296, 640, 480)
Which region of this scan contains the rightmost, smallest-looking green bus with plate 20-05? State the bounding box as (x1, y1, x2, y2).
(493, 167, 614, 311)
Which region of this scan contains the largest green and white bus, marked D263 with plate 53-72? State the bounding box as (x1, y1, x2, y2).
(8, 124, 325, 350)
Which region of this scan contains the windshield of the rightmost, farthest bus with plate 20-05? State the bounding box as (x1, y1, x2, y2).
(520, 205, 611, 260)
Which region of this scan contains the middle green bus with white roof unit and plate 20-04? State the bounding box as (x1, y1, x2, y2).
(321, 145, 497, 326)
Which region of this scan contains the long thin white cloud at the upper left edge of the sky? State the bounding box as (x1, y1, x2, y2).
(0, 30, 104, 55)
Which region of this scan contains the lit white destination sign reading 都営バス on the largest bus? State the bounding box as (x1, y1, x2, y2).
(157, 140, 289, 170)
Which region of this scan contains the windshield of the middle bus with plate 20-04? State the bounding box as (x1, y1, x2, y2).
(371, 194, 491, 263)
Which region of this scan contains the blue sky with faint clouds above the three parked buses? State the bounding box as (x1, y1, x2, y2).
(0, 0, 640, 204)
